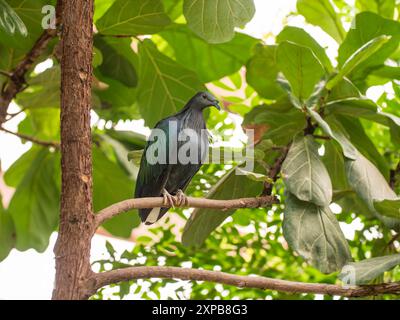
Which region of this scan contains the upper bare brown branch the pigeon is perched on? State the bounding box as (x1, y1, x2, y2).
(96, 196, 278, 227)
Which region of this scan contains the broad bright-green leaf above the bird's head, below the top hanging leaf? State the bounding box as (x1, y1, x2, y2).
(160, 25, 258, 83)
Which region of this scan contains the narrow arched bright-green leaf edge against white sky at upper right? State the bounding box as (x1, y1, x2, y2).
(276, 26, 333, 72)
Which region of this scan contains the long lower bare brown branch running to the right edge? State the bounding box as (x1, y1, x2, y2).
(91, 267, 400, 297)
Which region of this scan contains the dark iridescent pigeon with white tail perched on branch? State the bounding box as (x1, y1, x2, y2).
(135, 92, 221, 225)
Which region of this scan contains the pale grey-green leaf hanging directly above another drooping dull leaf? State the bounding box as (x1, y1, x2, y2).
(281, 136, 332, 206)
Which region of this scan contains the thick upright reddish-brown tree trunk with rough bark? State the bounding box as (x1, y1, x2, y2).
(53, 0, 94, 299)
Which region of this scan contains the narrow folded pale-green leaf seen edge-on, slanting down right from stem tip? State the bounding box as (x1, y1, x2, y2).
(307, 109, 357, 160)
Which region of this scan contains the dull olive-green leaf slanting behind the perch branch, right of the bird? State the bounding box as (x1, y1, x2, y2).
(182, 168, 262, 247)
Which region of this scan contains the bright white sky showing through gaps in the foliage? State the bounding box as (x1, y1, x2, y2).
(0, 0, 390, 299)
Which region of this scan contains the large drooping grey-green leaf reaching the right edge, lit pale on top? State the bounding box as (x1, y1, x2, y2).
(345, 153, 400, 230)
